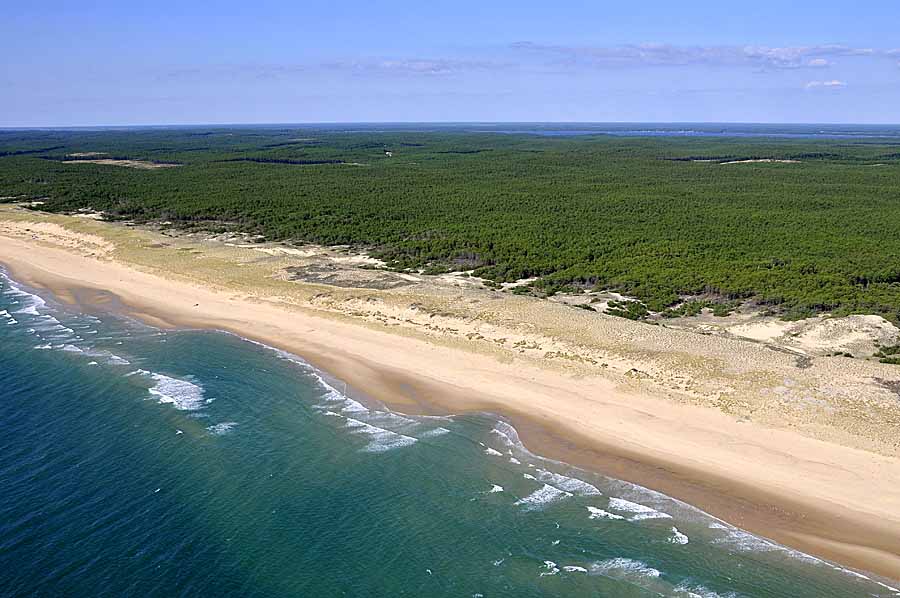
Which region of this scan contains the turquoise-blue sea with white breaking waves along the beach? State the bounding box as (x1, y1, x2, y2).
(0, 276, 900, 598)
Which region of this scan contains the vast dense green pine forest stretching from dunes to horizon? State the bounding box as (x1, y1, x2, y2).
(0, 123, 900, 323)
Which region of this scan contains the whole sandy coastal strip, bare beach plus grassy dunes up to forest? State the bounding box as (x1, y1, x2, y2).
(0, 207, 900, 580)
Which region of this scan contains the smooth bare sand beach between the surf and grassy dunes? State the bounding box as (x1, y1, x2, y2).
(0, 223, 900, 579)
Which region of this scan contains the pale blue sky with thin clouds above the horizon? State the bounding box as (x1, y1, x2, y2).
(0, 0, 900, 126)
